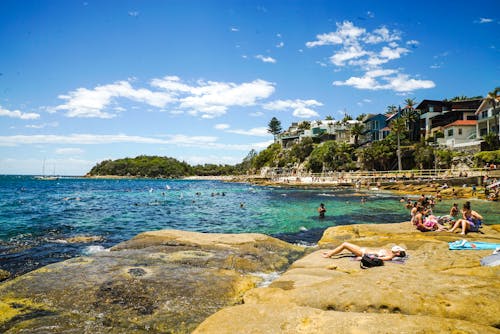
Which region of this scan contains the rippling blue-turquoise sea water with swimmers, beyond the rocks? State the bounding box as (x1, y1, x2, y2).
(0, 176, 500, 275)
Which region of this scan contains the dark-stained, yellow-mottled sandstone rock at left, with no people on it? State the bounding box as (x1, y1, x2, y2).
(0, 231, 304, 333)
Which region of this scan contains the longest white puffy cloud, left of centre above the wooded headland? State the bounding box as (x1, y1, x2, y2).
(56, 76, 274, 118)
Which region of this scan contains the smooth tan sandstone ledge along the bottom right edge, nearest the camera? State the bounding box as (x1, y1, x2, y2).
(193, 303, 498, 334)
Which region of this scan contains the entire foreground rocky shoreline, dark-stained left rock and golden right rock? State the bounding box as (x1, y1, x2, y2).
(0, 222, 500, 333)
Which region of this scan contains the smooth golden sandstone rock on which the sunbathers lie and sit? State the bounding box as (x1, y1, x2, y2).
(196, 222, 500, 333)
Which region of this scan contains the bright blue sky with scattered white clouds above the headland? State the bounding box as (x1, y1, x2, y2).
(0, 0, 500, 175)
